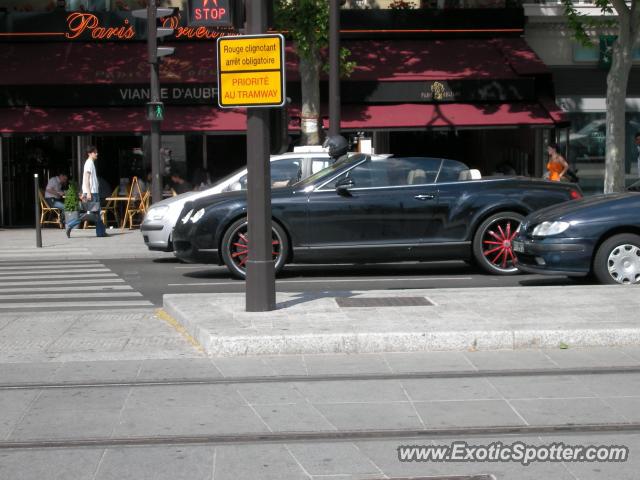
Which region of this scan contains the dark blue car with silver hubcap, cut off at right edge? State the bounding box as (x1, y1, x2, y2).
(513, 192, 640, 284)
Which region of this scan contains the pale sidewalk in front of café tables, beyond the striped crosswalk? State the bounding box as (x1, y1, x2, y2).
(0, 228, 173, 261)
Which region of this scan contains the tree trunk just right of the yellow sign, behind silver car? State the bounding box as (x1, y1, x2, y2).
(299, 53, 320, 145)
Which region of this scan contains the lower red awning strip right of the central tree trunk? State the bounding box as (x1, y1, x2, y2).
(324, 103, 555, 130)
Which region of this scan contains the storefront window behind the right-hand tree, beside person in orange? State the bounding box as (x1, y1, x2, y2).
(559, 112, 640, 195)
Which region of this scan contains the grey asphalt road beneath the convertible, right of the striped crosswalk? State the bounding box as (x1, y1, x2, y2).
(103, 259, 592, 306)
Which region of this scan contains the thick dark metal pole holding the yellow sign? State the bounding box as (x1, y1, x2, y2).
(246, 0, 276, 312)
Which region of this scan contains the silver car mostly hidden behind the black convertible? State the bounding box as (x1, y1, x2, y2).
(140, 151, 330, 252)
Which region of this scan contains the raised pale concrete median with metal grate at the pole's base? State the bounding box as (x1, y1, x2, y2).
(164, 285, 640, 356)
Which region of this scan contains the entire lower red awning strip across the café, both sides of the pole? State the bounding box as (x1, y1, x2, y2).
(0, 101, 564, 134)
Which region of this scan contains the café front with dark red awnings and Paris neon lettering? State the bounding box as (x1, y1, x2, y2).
(0, 0, 567, 226)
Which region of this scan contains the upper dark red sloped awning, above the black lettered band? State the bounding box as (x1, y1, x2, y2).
(0, 38, 549, 85)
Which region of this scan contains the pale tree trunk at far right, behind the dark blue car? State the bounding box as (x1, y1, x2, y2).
(604, 34, 632, 193)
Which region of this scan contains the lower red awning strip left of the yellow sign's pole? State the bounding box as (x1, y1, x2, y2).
(0, 106, 247, 133)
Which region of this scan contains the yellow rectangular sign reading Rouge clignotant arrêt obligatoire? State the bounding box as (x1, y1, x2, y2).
(217, 34, 285, 108)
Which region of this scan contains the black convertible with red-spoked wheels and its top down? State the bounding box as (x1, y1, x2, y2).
(173, 154, 582, 278)
